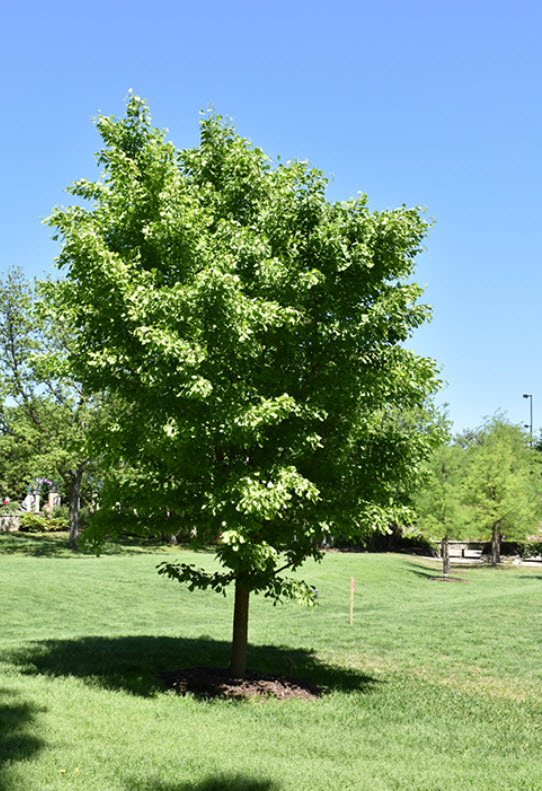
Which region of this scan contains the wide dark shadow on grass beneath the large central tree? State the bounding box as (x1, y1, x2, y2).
(8, 635, 381, 697)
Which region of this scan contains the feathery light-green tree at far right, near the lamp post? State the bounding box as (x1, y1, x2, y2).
(466, 416, 542, 566)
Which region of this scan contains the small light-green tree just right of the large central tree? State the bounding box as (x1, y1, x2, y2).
(416, 444, 472, 578)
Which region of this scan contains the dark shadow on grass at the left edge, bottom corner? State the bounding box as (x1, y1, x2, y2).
(0, 689, 45, 791)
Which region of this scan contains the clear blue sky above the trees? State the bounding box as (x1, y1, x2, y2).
(0, 0, 542, 433)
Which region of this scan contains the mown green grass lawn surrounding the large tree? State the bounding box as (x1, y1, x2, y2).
(0, 535, 542, 791)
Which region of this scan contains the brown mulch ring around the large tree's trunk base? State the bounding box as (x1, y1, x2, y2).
(158, 667, 322, 700)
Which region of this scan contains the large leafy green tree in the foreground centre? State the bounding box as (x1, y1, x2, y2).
(49, 96, 437, 674)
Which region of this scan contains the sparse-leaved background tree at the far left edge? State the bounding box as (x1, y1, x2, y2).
(0, 269, 96, 550)
